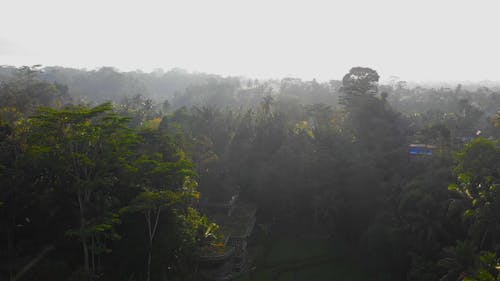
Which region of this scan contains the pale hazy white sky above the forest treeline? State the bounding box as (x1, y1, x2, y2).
(0, 0, 500, 82)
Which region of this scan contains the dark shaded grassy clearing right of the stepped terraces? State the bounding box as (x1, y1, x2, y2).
(234, 232, 369, 281)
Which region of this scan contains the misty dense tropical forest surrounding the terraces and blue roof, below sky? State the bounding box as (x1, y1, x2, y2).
(0, 66, 500, 281)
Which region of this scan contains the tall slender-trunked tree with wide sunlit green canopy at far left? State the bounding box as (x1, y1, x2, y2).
(26, 103, 139, 274)
